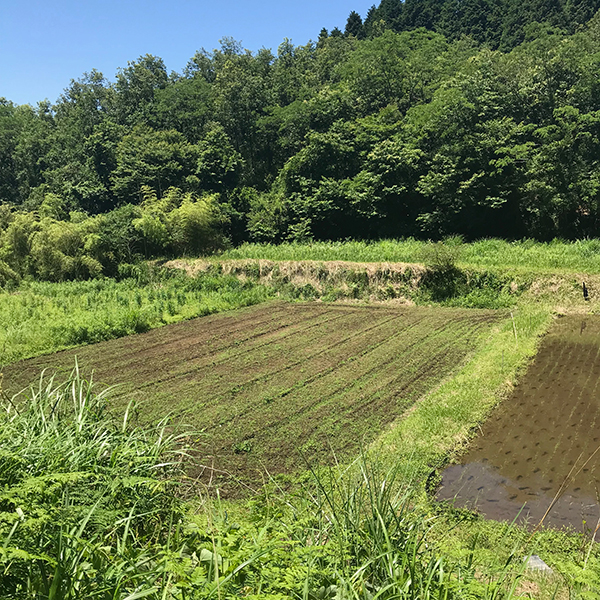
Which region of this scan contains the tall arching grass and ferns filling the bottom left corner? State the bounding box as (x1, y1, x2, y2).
(0, 368, 190, 600)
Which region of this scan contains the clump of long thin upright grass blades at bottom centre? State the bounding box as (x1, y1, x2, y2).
(302, 458, 485, 600)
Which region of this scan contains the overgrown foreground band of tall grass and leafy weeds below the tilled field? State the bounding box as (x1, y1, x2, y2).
(0, 369, 568, 600)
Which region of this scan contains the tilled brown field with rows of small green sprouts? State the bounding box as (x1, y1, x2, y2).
(5, 303, 506, 490)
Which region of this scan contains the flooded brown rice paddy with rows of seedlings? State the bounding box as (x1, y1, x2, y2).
(437, 316, 600, 530)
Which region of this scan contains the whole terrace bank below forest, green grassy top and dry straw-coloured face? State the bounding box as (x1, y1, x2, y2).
(167, 239, 600, 311)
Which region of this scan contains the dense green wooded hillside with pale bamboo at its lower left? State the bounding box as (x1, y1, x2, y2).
(0, 0, 600, 284)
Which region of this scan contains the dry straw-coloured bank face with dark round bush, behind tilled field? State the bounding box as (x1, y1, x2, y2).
(167, 257, 530, 309)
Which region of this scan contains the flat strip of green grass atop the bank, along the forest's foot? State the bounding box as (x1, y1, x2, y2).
(214, 238, 600, 273)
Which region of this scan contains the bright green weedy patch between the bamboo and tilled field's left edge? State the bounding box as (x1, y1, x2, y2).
(0, 265, 273, 364)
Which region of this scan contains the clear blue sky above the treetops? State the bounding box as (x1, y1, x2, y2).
(0, 0, 378, 104)
